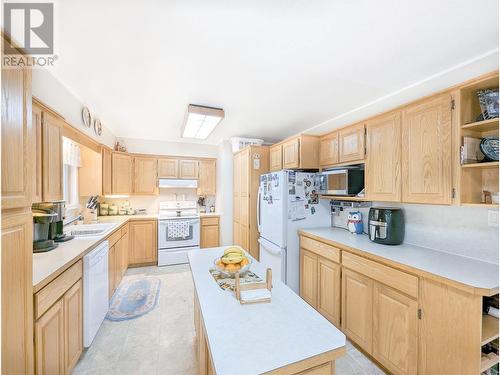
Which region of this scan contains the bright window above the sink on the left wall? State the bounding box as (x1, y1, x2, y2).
(63, 137, 81, 211)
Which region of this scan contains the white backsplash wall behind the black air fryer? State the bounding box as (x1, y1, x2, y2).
(334, 202, 499, 264)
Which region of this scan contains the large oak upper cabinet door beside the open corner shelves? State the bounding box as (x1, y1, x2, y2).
(402, 94, 451, 204)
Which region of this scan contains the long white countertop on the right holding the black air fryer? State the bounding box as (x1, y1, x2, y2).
(301, 227, 498, 289)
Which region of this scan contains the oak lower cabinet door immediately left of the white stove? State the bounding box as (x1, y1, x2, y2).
(129, 221, 158, 264)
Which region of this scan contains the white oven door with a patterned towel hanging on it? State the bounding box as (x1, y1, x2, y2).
(158, 218, 200, 249)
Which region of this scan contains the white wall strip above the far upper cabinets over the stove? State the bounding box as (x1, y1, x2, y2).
(117, 137, 218, 158)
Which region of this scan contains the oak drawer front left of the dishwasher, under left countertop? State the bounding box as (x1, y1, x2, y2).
(34, 260, 82, 319)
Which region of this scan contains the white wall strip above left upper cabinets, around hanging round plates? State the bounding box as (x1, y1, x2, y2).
(32, 69, 115, 147)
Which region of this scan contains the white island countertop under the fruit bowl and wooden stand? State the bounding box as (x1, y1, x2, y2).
(189, 247, 345, 375)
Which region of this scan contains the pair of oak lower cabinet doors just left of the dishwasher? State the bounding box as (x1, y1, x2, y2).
(35, 279, 83, 375)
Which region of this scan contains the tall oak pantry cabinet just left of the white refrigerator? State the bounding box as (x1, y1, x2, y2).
(233, 146, 269, 260)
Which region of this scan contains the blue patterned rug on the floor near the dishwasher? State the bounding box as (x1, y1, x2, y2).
(106, 276, 161, 321)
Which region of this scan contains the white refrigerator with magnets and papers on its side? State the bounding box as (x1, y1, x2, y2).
(257, 170, 330, 294)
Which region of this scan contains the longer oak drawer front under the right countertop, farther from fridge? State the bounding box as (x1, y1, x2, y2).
(342, 251, 418, 298)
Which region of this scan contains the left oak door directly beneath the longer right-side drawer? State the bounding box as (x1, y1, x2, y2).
(342, 268, 373, 353)
